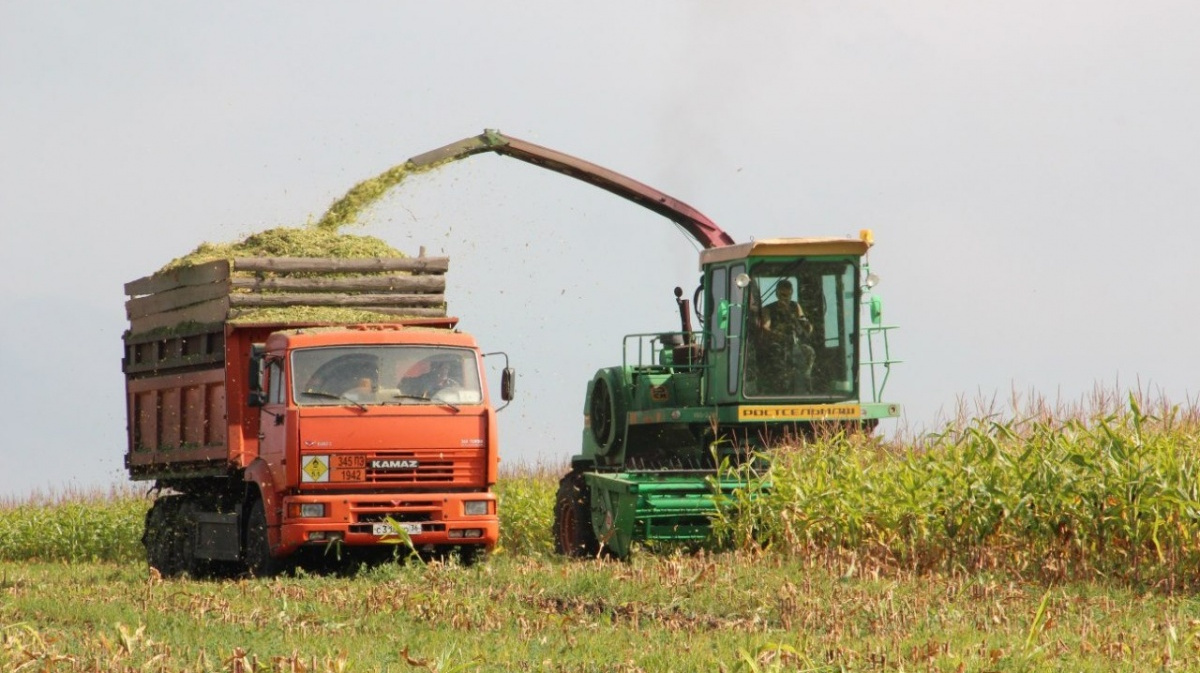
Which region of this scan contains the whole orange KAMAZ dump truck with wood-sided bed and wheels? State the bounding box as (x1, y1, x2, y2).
(124, 257, 514, 575)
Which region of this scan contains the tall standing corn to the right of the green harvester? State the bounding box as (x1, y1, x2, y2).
(715, 396, 1200, 589)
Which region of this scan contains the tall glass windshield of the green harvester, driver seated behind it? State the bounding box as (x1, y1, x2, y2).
(742, 259, 858, 399)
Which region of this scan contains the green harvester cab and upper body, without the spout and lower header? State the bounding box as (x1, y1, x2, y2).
(575, 230, 899, 469)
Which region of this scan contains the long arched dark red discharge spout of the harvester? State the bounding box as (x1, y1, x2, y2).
(408, 128, 734, 248)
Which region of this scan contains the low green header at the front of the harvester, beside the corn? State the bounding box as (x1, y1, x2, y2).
(584, 471, 745, 558)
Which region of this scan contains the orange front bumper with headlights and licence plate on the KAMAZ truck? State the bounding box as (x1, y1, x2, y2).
(275, 493, 500, 555)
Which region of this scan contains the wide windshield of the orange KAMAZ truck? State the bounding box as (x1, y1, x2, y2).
(292, 345, 484, 407)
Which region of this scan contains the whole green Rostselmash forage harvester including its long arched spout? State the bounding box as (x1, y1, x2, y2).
(409, 131, 900, 558)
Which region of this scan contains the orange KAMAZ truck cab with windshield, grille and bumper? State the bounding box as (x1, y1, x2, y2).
(247, 325, 508, 563)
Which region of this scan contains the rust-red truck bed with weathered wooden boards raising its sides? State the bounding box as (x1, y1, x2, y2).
(122, 257, 449, 480)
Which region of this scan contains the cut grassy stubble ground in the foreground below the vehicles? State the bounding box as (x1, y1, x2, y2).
(7, 554, 1200, 672)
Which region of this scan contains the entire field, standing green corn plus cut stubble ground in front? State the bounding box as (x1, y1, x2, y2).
(0, 399, 1200, 673)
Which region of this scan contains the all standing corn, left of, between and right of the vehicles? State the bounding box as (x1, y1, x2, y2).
(0, 396, 1200, 590)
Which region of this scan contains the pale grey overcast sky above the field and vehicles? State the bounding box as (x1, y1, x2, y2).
(0, 0, 1200, 497)
